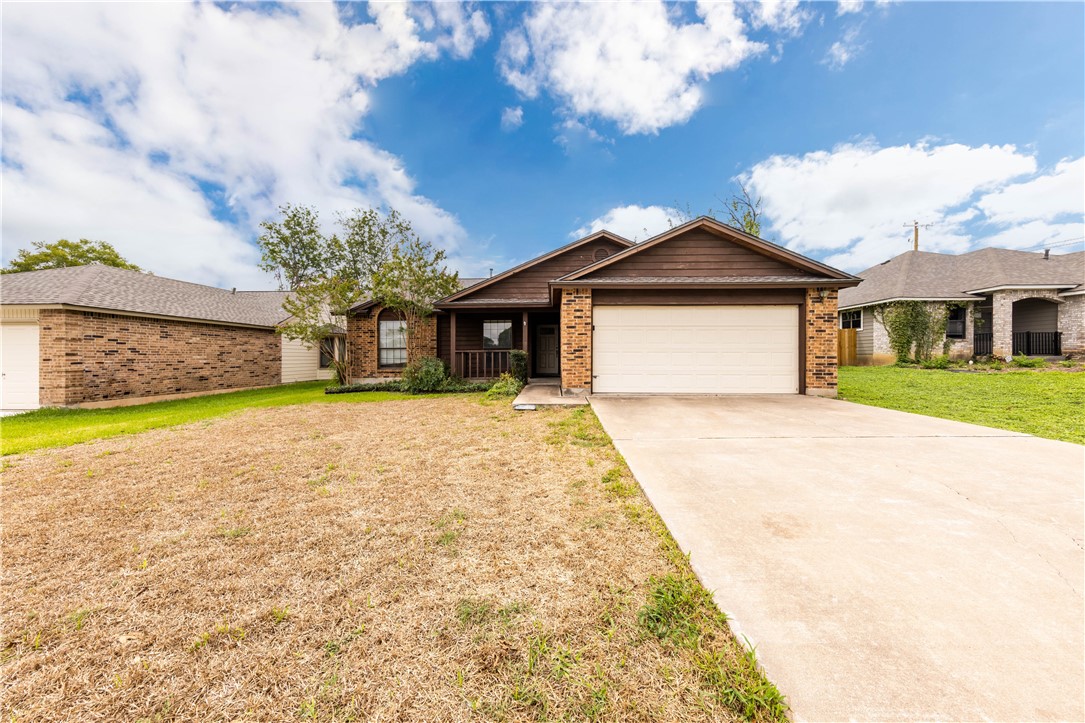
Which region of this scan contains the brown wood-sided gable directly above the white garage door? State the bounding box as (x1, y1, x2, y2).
(556, 216, 859, 286)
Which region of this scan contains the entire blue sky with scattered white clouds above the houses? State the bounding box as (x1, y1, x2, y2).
(2, 2, 1085, 288)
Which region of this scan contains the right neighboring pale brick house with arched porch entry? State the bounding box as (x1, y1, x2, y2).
(840, 249, 1085, 365)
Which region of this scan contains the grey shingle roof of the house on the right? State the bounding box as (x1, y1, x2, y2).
(840, 249, 1085, 308)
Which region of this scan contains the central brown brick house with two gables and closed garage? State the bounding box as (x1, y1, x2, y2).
(347, 217, 859, 395)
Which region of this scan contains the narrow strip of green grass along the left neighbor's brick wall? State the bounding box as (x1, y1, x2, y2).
(0, 381, 417, 455)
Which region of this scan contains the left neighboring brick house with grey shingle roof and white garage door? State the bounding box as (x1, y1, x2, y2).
(0, 264, 345, 410)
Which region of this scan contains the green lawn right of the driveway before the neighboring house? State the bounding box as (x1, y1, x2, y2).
(840, 367, 1085, 444)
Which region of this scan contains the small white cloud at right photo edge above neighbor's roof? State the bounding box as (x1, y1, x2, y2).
(977, 156, 1085, 224)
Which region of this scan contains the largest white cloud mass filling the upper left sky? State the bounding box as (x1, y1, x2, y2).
(2, 3, 489, 287)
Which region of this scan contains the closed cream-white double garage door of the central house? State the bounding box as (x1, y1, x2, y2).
(591, 306, 799, 394)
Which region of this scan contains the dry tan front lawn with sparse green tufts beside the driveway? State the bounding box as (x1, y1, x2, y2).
(0, 397, 782, 721)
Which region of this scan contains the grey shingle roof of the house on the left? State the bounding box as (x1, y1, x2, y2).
(0, 264, 290, 327)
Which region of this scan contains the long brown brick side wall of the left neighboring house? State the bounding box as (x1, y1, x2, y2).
(39, 309, 282, 406)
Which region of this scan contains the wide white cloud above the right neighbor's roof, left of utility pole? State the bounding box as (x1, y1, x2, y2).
(743, 143, 1050, 270)
